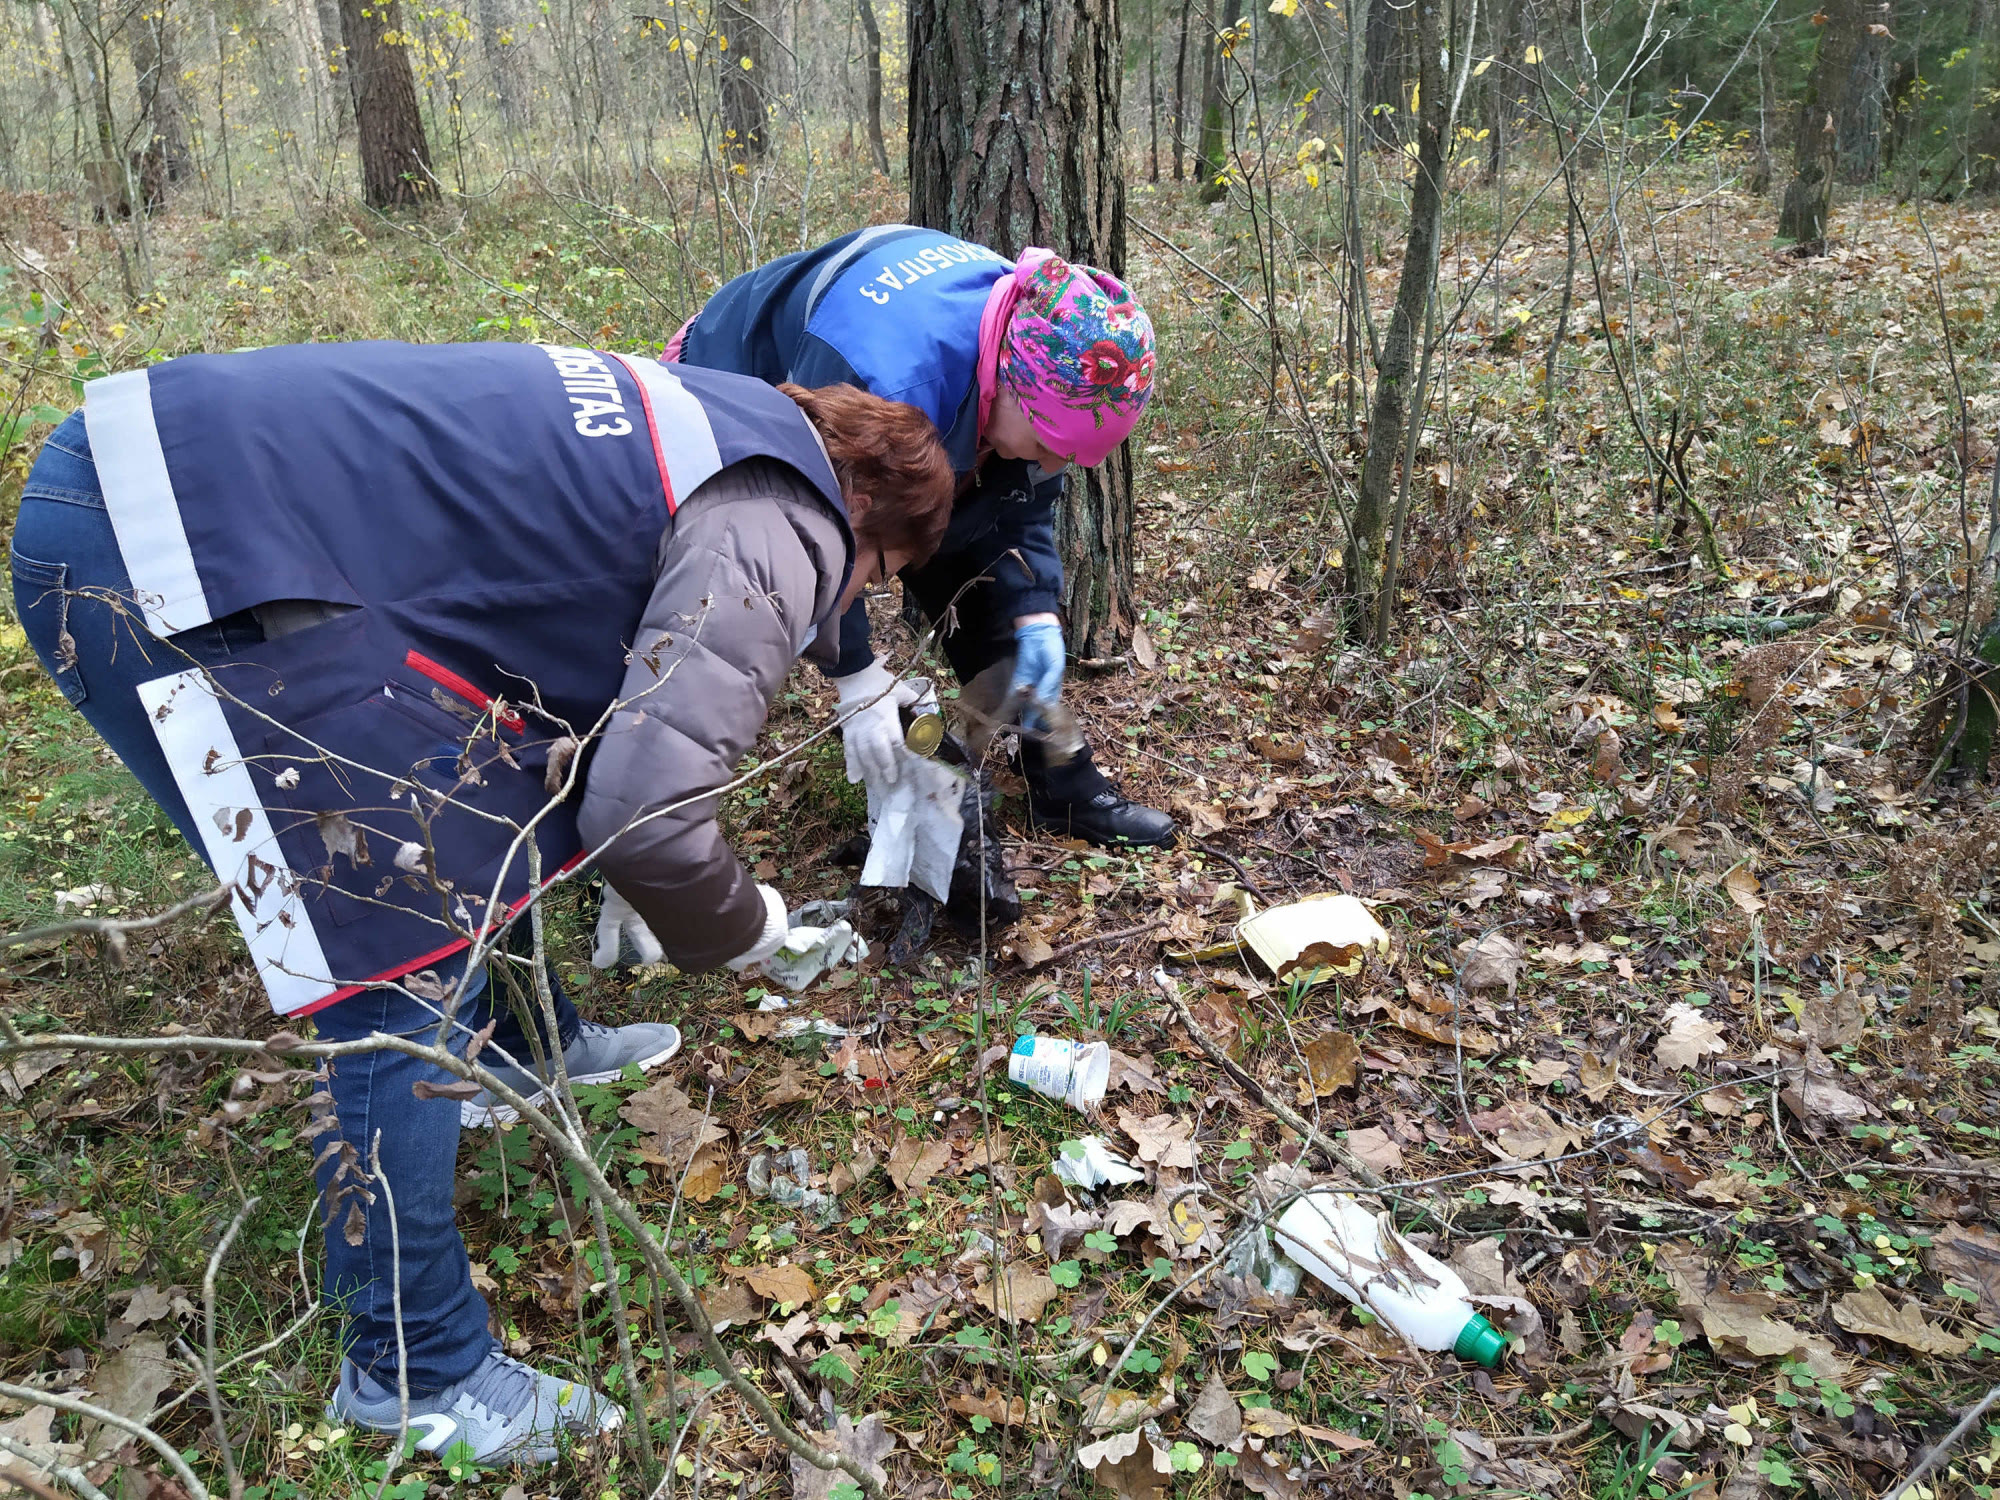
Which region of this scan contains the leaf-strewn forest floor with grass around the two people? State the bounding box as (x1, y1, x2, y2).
(0, 150, 2000, 1500)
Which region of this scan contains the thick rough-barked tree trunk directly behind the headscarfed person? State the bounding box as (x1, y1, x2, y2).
(910, 0, 1132, 656)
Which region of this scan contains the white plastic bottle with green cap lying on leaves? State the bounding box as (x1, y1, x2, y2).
(1276, 1192, 1506, 1370)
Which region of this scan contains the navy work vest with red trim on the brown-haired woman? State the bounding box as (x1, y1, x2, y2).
(84, 342, 852, 1014)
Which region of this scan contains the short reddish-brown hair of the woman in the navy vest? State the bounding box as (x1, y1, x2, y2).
(778, 384, 958, 562)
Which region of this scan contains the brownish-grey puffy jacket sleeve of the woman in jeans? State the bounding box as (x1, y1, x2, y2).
(576, 458, 846, 972)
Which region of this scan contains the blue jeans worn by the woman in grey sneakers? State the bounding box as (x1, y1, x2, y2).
(12, 412, 580, 1394)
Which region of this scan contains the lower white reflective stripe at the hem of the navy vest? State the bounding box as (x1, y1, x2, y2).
(141, 672, 338, 1016)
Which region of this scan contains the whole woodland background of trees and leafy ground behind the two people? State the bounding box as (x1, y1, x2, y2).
(0, 0, 2000, 1500)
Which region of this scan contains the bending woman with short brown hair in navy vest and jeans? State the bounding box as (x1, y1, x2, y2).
(12, 344, 952, 1464)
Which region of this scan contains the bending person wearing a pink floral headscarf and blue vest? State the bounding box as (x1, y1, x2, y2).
(664, 224, 1174, 844)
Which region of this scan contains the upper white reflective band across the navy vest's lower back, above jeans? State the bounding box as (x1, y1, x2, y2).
(84, 370, 216, 636)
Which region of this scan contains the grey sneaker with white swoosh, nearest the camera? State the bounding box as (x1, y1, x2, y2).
(326, 1348, 624, 1466)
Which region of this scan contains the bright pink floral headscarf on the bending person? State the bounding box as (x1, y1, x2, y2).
(980, 250, 1154, 468)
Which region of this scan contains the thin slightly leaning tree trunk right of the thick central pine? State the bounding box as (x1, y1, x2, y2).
(1346, 0, 1458, 638)
